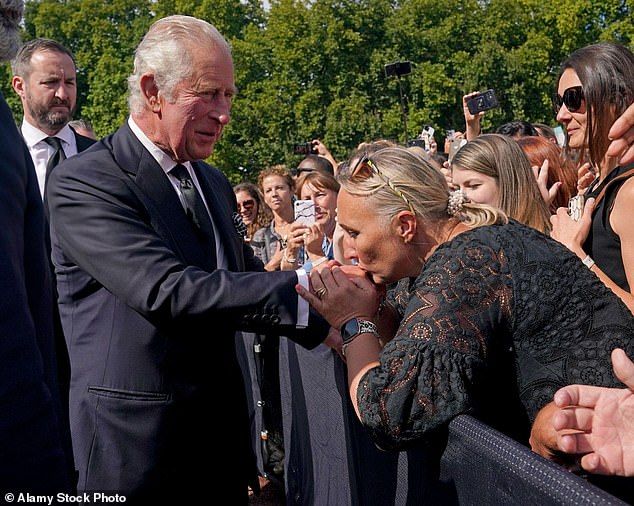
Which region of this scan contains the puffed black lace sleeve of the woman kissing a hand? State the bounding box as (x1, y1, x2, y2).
(357, 241, 511, 449)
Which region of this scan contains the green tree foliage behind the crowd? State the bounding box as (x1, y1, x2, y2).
(0, 0, 634, 182)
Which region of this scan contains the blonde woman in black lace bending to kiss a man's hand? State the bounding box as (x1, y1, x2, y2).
(298, 147, 634, 500)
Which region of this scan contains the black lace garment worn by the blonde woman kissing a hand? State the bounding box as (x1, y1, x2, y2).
(357, 221, 634, 449)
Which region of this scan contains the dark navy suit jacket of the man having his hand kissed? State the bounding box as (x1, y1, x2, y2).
(47, 124, 328, 504)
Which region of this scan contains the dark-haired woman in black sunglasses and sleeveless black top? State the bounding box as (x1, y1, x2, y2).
(551, 42, 634, 312)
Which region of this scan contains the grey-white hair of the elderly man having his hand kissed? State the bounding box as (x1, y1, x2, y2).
(128, 15, 231, 115)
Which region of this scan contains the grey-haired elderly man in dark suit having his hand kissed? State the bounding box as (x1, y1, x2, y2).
(47, 16, 328, 504)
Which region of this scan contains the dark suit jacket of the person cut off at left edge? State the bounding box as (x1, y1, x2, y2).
(0, 94, 70, 496)
